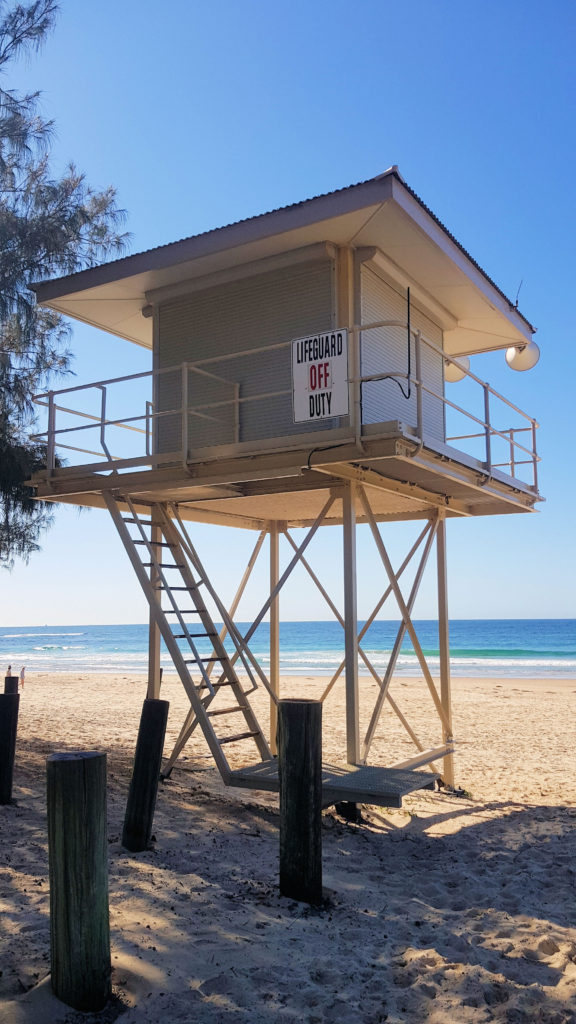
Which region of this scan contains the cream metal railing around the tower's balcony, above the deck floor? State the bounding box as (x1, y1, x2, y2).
(35, 321, 539, 492)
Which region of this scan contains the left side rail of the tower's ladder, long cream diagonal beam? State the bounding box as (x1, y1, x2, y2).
(104, 492, 232, 785)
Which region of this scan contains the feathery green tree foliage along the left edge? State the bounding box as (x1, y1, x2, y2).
(0, 0, 126, 567)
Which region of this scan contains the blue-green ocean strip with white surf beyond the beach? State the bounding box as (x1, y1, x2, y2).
(0, 618, 576, 679)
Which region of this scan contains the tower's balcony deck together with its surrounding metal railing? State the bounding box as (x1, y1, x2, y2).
(31, 322, 541, 529)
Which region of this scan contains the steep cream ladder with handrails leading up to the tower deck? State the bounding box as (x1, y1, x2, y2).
(106, 494, 272, 785)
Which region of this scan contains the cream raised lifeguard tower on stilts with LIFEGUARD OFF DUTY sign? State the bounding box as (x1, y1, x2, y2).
(28, 167, 539, 805)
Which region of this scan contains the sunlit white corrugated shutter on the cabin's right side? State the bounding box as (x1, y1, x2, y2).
(361, 265, 445, 440)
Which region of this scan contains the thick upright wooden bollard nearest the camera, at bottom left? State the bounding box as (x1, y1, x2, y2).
(46, 751, 111, 1013)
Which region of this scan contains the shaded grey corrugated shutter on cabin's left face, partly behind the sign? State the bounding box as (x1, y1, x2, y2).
(158, 258, 340, 452)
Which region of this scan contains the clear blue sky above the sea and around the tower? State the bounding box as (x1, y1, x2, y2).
(0, 0, 576, 625)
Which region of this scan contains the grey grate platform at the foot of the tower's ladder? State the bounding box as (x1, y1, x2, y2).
(229, 760, 439, 807)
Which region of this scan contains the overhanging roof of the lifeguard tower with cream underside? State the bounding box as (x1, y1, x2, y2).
(32, 168, 534, 354)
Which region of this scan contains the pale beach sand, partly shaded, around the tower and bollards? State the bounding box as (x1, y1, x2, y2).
(0, 674, 576, 1024)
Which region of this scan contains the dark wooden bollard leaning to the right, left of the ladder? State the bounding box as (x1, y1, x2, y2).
(122, 697, 170, 853)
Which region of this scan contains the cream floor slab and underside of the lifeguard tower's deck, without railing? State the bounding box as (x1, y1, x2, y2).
(33, 437, 540, 529)
